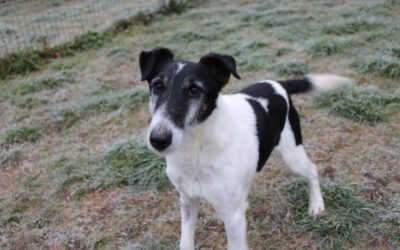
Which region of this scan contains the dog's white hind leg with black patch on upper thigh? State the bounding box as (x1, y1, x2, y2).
(277, 116, 325, 215)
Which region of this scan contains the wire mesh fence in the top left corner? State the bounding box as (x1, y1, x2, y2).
(0, 0, 165, 56)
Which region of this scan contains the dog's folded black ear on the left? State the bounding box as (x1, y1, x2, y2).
(139, 48, 174, 81)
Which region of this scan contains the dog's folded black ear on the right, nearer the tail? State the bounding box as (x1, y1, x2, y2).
(199, 53, 240, 87)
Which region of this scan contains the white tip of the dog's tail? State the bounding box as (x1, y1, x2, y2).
(307, 74, 353, 92)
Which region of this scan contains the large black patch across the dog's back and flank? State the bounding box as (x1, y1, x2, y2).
(240, 83, 288, 171)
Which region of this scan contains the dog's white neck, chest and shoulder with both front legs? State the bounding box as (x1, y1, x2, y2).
(166, 94, 258, 249)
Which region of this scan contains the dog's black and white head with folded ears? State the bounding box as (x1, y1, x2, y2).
(139, 48, 240, 154)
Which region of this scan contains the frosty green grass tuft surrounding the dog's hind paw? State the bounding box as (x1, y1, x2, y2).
(284, 179, 376, 248)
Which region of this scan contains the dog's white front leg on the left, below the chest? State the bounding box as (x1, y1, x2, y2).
(180, 193, 199, 250)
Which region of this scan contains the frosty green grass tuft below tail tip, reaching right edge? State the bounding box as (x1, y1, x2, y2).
(314, 86, 400, 125)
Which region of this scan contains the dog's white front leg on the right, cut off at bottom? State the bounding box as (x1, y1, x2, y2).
(224, 209, 248, 250)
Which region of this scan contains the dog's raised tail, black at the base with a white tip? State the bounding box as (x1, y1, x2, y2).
(279, 74, 353, 94)
